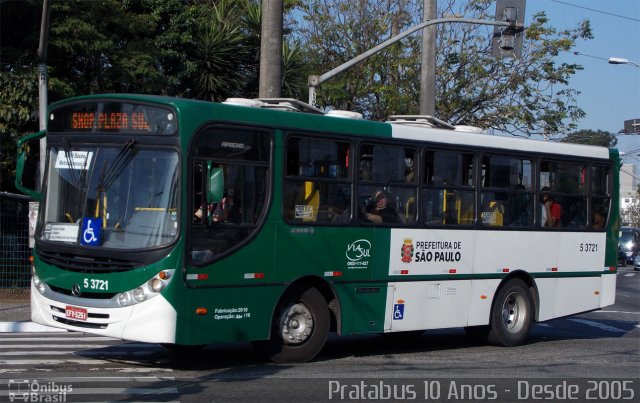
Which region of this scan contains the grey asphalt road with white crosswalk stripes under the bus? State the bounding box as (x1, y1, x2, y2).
(0, 267, 640, 402)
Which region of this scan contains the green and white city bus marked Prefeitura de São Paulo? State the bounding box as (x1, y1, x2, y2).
(16, 94, 620, 362)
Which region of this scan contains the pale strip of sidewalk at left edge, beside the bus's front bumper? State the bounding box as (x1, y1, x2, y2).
(0, 293, 66, 333)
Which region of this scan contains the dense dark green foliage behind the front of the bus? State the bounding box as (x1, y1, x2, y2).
(0, 0, 308, 190)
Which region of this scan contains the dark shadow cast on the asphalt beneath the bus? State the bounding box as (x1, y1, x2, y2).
(76, 317, 638, 375)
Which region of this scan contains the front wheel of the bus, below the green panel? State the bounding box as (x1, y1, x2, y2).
(253, 288, 330, 363)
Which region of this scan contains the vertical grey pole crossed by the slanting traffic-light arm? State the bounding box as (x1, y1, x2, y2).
(420, 0, 437, 116)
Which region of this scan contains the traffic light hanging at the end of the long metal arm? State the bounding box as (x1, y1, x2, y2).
(491, 0, 525, 59)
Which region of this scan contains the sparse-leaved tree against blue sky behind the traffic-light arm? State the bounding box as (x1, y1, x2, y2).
(300, 0, 592, 137)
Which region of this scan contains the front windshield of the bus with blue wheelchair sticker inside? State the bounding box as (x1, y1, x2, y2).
(39, 140, 179, 249)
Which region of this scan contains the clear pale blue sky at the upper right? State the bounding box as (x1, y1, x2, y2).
(525, 0, 640, 158)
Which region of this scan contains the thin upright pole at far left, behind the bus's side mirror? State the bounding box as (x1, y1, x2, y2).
(36, 0, 49, 190)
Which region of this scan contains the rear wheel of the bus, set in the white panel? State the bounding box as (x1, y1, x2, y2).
(487, 278, 533, 347)
